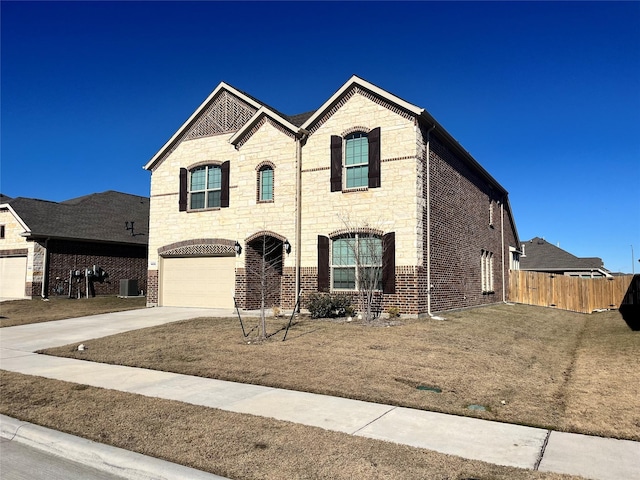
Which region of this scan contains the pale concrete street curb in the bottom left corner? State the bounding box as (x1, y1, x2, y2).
(0, 414, 228, 480)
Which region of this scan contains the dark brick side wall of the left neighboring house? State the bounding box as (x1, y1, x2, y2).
(47, 240, 147, 295)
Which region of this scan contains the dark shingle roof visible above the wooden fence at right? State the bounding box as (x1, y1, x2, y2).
(520, 237, 603, 270)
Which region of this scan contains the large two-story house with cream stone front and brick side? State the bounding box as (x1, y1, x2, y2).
(145, 76, 519, 315)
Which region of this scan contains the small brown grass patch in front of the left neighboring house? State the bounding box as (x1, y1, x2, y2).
(0, 296, 146, 327)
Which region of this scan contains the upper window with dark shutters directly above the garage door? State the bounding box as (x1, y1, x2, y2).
(178, 161, 230, 212)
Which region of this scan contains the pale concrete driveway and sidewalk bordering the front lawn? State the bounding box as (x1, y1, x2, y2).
(0, 307, 640, 480)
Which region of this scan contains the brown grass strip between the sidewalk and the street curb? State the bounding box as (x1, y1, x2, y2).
(0, 371, 578, 480)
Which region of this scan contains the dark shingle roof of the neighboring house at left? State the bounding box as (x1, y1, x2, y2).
(7, 190, 149, 244)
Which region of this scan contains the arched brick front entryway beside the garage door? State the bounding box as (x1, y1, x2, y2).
(245, 232, 285, 309)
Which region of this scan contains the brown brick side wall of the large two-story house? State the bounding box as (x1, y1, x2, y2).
(423, 135, 512, 312)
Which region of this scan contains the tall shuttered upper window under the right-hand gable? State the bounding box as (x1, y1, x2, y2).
(331, 127, 380, 192)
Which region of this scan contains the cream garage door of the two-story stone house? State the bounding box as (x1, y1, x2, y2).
(160, 257, 236, 308)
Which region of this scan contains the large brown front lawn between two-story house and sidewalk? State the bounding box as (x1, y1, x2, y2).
(44, 305, 640, 440)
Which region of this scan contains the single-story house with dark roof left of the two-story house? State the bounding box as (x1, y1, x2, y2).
(0, 191, 149, 298)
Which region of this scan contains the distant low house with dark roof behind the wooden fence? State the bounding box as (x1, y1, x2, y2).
(520, 237, 612, 278)
